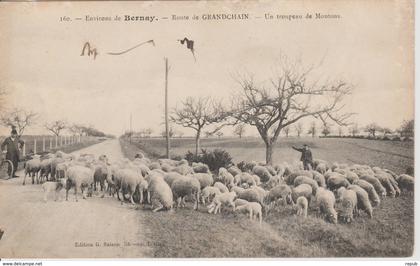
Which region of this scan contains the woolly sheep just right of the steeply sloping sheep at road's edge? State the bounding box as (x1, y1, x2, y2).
(171, 176, 201, 210)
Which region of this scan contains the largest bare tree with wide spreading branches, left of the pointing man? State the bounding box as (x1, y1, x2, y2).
(228, 60, 352, 164)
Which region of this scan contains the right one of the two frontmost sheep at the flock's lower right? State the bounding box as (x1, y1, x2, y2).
(337, 187, 358, 223)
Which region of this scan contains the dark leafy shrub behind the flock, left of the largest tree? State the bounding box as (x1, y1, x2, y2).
(185, 149, 233, 171)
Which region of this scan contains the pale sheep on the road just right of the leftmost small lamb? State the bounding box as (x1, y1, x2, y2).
(66, 165, 93, 201)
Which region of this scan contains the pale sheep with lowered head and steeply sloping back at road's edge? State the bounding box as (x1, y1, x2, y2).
(145, 172, 173, 212)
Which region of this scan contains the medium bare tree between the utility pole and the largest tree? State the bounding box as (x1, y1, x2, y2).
(170, 97, 224, 155)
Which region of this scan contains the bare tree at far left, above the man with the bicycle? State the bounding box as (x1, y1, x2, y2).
(0, 108, 37, 136)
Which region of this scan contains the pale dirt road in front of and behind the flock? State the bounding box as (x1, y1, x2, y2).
(0, 139, 150, 258)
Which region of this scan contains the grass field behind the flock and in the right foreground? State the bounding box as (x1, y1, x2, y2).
(121, 138, 414, 257)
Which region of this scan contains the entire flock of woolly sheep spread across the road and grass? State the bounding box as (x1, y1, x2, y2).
(23, 151, 414, 223)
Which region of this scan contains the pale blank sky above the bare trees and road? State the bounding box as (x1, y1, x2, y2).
(0, 0, 414, 135)
